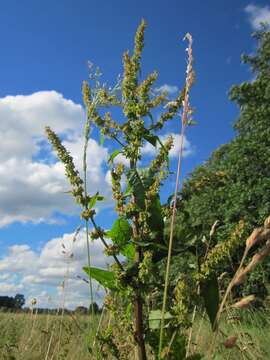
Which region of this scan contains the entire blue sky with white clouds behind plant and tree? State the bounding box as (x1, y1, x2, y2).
(0, 0, 270, 307)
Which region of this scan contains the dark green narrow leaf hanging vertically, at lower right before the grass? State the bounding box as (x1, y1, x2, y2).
(201, 276, 219, 330)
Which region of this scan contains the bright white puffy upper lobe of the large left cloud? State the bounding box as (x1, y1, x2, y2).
(0, 91, 84, 161)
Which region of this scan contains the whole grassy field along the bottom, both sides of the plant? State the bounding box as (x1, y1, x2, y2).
(0, 310, 270, 360)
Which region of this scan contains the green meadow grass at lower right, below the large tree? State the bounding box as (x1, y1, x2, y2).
(190, 308, 270, 360)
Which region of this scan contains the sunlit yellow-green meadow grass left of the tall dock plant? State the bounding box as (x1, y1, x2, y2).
(0, 313, 99, 360)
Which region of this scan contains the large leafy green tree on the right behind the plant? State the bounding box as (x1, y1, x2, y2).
(169, 26, 270, 296)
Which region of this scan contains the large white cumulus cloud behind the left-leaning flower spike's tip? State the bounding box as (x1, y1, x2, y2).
(0, 91, 109, 227)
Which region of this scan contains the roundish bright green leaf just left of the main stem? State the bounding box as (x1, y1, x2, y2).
(107, 218, 132, 249)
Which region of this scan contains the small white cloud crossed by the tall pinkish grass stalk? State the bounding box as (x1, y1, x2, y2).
(142, 133, 193, 158)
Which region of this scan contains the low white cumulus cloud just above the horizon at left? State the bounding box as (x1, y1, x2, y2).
(0, 231, 111, 308)
